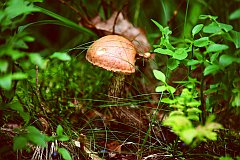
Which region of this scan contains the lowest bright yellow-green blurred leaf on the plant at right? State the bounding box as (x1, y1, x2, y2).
(179, 128, 197, 144)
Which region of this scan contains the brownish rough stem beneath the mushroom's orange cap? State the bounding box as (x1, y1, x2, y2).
(108, 72, 126, 102)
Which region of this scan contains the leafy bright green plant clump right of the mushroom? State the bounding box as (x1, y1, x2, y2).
(152, 15, 240, 147)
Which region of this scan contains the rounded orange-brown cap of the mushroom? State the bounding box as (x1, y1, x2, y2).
(86, 35, 136, 74)
